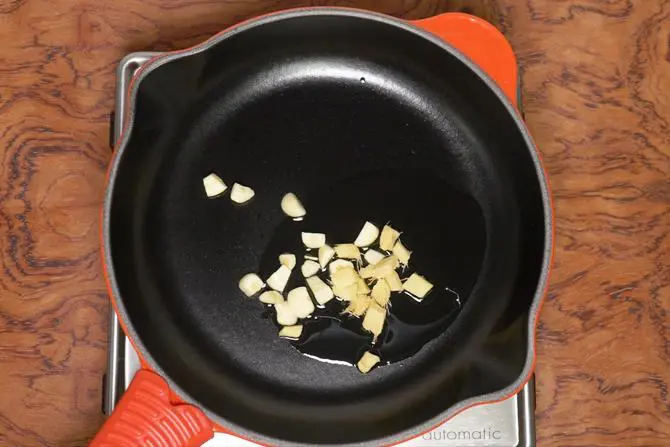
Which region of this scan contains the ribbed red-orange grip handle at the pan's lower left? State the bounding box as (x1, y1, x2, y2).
(90, 370, 214, 447)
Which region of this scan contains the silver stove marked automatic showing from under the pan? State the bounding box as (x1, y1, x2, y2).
(103, 52, 535, 447)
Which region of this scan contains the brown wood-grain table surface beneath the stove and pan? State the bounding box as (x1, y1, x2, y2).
(0, 0, 670, 447)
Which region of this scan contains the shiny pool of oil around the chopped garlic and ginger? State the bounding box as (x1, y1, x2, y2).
(260, 170, 486, 365)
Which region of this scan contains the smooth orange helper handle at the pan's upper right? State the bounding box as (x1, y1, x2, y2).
(411, 12, 519, 106)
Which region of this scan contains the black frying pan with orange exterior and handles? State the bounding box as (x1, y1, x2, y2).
(92, 8, 552, 446)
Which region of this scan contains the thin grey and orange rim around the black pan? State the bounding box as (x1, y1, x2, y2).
(102, 7, 554, 446)
